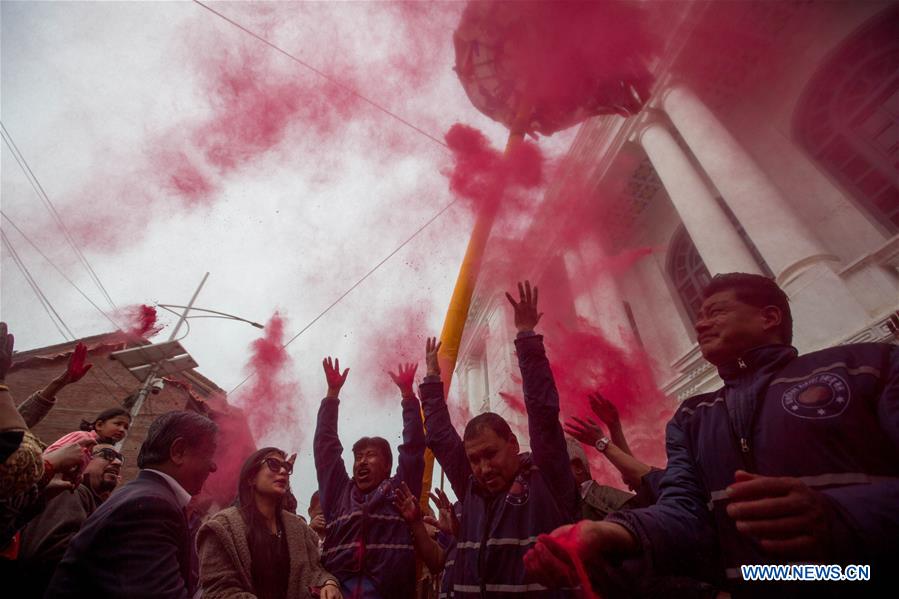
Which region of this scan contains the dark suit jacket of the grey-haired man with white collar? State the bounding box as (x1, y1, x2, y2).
(46, 471, 192, 599)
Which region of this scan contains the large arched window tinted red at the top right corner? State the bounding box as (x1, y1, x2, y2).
(794, 6, 899, 234)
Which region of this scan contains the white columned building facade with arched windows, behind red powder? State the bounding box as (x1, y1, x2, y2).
(455, 2, 899, 439)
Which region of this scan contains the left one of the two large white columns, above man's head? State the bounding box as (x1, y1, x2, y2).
(640, 119, 761, 276)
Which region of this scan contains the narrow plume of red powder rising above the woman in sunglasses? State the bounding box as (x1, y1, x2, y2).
(235, 312, 303, 445)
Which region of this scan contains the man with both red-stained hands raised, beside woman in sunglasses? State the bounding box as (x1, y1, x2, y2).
(313, 358, 425, 599)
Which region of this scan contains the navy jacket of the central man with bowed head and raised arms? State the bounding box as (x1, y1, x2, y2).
(420, 334, 578, 599)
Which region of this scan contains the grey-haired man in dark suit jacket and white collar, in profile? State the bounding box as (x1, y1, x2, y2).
(46, 412, 217, 599)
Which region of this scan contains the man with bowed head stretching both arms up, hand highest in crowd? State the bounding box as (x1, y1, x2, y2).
(420, 281, 578, 599)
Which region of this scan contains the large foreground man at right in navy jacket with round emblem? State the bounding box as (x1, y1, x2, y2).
(526, 273, 899, 597)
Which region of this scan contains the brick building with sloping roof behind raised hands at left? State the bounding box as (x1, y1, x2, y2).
(6, 332, 255, 505)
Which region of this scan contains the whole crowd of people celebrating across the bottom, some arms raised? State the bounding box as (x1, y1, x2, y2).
(0, 273, 899, 599)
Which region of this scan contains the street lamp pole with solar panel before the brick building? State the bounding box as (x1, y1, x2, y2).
(110, 272, 264, 449)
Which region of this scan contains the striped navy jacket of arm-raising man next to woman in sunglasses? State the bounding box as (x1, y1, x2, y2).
(313, 398, 425, 599)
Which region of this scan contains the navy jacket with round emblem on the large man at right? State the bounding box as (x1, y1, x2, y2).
(608, 343, 899, 590)
